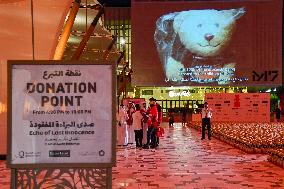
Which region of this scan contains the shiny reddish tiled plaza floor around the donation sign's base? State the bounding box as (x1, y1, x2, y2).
(0, 124, 284, 189)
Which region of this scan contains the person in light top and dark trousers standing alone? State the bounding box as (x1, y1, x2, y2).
(201, 102, 212, 140)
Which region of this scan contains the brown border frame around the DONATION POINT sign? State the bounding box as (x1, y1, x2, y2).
(7, 60, 116, 169)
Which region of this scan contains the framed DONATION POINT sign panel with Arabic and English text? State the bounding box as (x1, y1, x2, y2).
(8, 61, 116, 168)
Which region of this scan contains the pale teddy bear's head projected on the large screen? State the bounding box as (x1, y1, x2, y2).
(173, 8, 244, 57)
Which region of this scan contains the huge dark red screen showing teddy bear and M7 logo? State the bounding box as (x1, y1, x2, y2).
(131, 0, 282, 86)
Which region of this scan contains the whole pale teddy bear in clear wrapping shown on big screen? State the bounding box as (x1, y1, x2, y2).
(154, 8, 245, 84)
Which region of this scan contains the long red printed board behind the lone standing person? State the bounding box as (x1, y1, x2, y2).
(205, 93, 270, 122)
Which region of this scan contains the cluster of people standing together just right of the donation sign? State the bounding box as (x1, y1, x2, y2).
(117, 97, 163, 149)
